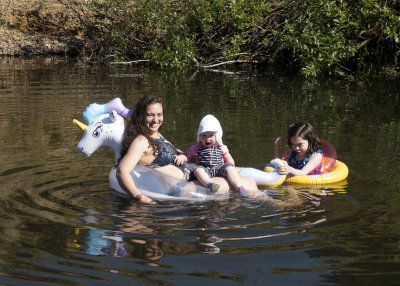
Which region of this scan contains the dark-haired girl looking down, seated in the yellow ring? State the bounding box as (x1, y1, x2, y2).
(275, 122, 322, 176)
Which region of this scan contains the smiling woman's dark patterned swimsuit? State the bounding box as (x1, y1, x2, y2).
(148, 137, 194, 180)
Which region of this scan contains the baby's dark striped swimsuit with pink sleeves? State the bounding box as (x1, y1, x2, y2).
(185, 142, 233, 180)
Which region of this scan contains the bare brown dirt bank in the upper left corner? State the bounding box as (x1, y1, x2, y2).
(0, 0, 85, 55)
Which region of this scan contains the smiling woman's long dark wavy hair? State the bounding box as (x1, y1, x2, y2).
(119, 95, 164, 160)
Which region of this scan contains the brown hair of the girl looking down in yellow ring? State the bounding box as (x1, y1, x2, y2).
(288, 122, 321, 154)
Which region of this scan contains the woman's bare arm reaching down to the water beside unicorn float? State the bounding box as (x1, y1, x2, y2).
(117, 135, 152, 203)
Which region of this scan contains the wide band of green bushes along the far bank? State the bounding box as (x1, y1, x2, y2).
(71, 0, 400, 78)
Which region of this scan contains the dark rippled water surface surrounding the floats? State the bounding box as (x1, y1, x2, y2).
(0, 58, 400, 285)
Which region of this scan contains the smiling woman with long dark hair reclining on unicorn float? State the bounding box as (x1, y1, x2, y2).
(117, 96, 257, 203)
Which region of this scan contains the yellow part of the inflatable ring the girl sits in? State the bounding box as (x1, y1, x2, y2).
(265, 160, 349, 185)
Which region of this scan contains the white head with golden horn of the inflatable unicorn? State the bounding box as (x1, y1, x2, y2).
(73, 110, 125, 162)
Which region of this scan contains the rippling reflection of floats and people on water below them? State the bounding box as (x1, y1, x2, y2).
(73, 187, 338, 267)
